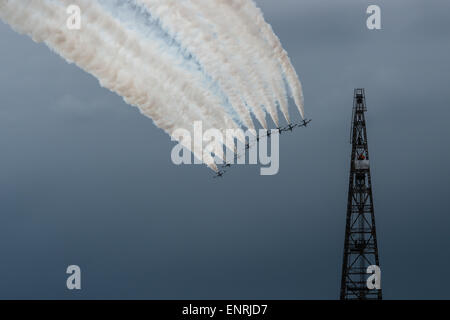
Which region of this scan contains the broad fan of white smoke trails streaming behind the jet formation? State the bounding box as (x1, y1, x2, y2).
(0, 0, 303, 171)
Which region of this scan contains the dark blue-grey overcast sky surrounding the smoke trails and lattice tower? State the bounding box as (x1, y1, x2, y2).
(0, 0, 450, 299)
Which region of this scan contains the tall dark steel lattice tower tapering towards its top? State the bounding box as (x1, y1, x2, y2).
(340, 89, 382, 300)
